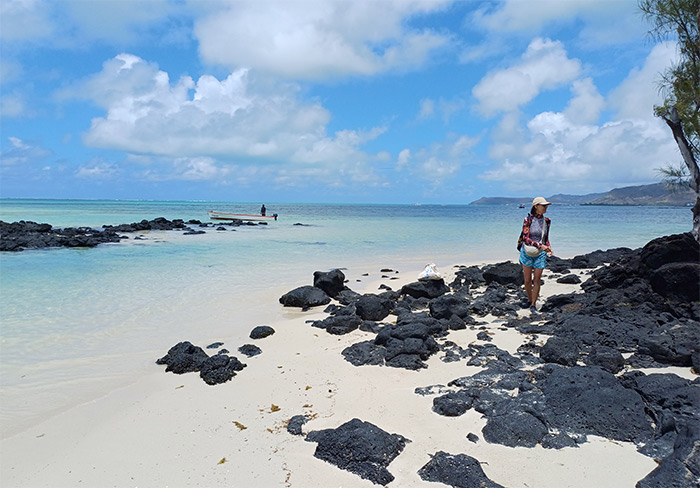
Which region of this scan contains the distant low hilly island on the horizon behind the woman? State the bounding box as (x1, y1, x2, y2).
(469, 183, 695, 207)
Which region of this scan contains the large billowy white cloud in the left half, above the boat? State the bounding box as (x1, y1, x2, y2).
(70, 54, 386, 185)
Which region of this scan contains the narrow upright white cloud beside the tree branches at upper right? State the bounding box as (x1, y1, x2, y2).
(608, 42, 678, 118)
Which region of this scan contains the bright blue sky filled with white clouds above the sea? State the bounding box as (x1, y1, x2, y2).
(0, 0, 681, 204)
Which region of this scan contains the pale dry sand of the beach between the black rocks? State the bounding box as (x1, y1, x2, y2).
(0, 266, 690, 488)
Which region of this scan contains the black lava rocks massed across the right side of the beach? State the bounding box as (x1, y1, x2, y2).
(280, 234, 700, 488)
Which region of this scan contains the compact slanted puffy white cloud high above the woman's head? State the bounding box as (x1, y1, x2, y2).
(472, 38, 581, 115)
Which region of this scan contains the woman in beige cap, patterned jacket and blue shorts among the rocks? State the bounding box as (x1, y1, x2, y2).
(518, 197, 552, 313)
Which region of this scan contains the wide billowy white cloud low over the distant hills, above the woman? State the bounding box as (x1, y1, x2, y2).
(481, 106, 674, 193)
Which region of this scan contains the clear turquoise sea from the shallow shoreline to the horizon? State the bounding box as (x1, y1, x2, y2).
(0, 199, 692, 438)
